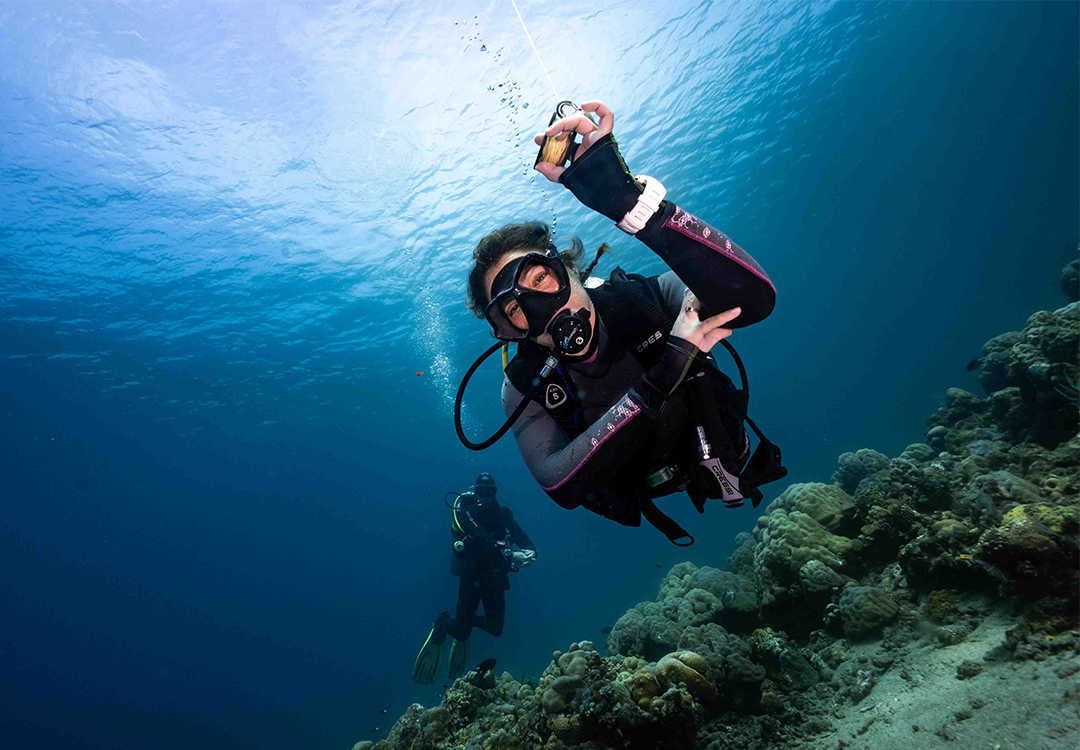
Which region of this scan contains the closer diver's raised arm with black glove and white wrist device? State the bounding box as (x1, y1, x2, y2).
(535, 102, 777, 327)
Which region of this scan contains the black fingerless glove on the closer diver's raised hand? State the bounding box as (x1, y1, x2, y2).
(558, 133, 645, 222)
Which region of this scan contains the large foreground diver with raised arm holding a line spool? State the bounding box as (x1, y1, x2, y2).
(455, 102, 787, 546)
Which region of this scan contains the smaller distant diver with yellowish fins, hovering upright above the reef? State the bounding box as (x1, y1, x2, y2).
(413, 472, 537, 684)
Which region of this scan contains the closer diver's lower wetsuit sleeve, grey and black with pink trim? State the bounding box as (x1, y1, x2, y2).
(502, 336, 699, 523)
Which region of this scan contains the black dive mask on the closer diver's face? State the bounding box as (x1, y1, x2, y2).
(484, 256, 574, 341)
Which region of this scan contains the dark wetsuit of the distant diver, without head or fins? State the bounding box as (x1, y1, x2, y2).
(446, 496, 536, 641)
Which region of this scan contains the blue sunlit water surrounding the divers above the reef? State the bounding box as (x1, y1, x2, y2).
(0, 0, 1080, 750)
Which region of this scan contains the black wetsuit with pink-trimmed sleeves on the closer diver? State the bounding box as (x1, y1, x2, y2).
(502, 199, 775, 525)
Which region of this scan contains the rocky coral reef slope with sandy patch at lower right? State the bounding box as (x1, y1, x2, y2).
(354, 262, 1080, 750)
